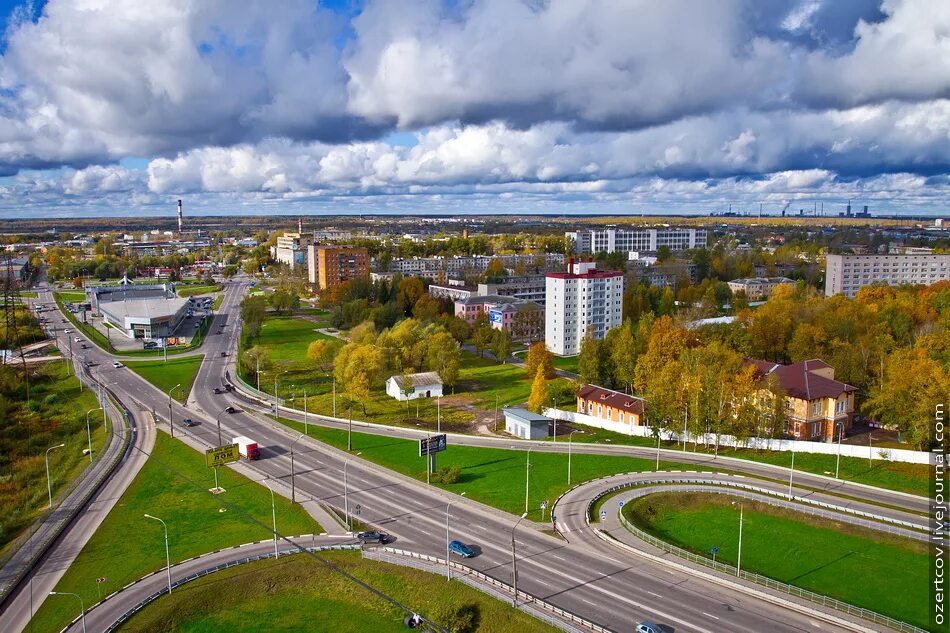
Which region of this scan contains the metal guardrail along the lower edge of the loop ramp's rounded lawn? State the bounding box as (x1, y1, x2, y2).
(591, 492, 927, 633)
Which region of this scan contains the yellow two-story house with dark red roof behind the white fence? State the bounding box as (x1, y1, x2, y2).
(746, 358, 857, 442)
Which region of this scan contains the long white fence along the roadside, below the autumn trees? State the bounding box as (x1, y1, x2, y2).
(544, 408, 931, 464)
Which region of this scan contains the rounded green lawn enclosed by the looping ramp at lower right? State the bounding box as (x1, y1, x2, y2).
(623, 493, 929, 627)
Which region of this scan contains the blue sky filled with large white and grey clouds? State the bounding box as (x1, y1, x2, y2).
(0, 0, 950, 217)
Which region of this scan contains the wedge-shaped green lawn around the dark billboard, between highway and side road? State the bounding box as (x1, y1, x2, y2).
(281, 418, 681, 521)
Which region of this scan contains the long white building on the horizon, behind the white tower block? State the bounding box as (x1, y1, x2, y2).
(564, 227, 706, 255)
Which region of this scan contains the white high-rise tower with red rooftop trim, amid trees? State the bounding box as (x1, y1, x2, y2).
(544, 259, 623, 356)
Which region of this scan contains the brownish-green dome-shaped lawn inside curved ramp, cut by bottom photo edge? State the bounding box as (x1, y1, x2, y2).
(119, 552, 557, 633)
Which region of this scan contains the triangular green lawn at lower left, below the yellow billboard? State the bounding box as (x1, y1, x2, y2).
(34, 432, 321, 631)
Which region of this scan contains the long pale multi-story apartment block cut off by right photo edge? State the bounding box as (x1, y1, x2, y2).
(825, 255, 950, 297)
